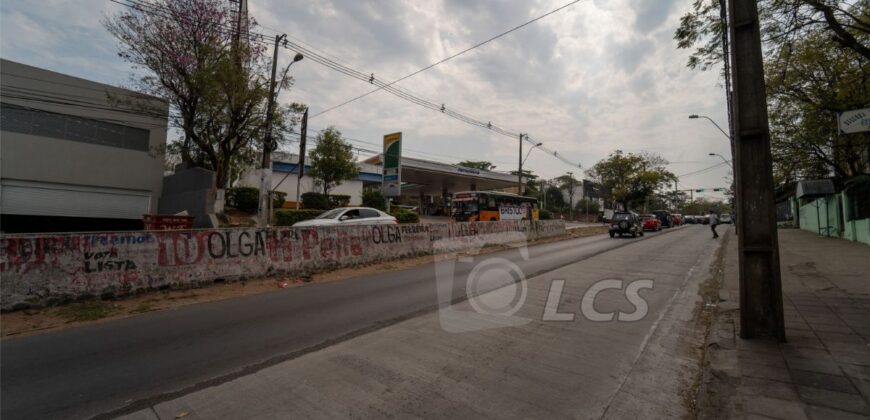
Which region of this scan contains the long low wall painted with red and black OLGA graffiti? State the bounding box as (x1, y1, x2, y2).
(0, 220, 565, 310)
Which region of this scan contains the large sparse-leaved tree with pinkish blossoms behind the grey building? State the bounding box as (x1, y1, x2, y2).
(103, 0, 304, 188)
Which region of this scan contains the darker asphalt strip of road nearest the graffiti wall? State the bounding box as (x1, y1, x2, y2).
(0, 225, 696, 419)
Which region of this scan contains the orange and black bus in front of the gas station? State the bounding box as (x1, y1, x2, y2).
(453, 191, 538, 222)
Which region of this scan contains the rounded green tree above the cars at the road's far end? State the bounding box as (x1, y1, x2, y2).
(586, 150, 676, 210)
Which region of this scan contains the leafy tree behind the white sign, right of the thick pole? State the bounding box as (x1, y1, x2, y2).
(766, 34, 870, 183)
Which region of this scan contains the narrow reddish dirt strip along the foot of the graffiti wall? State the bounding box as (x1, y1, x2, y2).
(0, 226, 607, 337)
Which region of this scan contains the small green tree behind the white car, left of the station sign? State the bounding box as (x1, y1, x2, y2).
(308, 127, 359, 196)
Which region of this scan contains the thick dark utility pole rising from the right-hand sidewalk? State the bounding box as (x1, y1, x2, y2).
(729, 0, 785, 341)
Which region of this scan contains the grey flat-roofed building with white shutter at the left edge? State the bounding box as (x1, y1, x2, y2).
(0, 60, 169, 232)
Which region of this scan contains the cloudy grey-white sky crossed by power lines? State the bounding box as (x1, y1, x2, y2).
(0, 0, 730, 197)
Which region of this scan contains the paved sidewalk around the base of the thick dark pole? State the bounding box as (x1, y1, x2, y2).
(699, 229, 870, 419)
